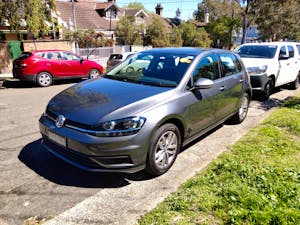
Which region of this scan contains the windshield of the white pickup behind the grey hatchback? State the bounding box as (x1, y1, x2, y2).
(237, 45, 277, 59)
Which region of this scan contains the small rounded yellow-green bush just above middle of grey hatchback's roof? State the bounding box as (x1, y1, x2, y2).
(179, 21, 211, 47)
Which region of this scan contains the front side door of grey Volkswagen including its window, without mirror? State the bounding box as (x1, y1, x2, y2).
(184, 54, 223, 137)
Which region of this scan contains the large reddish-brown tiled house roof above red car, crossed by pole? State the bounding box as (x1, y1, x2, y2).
(56, 0, 116, 30)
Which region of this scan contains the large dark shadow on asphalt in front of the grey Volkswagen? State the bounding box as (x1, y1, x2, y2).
(18, 139, 151, 188)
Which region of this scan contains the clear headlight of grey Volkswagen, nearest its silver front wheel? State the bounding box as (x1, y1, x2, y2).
(89, 116, 146, 137)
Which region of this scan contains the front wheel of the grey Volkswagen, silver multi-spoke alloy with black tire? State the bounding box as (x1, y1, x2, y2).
(145, 123, 181, 176)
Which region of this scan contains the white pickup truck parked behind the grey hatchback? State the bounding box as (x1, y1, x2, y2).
(236, 42, 300, 99)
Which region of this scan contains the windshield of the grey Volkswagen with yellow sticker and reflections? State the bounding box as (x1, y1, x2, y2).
(104, 53, 195, 87)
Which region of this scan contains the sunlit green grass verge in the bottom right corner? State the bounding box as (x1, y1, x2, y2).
(138, 96, 300, 225)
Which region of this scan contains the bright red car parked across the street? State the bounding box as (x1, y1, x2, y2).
(13, 50, 103, 87)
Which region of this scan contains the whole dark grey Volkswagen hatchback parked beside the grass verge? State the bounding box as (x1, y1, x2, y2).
(39, 48, 252, 176)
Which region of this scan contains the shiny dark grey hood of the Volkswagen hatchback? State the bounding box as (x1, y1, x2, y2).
(47, 78, 174, 124)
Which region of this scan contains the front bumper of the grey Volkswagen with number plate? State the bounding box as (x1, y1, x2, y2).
(39, 116, 148, 173)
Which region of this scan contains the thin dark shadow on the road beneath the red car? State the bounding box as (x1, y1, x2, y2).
(2, 79, 83, 89)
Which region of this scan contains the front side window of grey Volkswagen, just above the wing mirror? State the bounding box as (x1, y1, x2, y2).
(193, 55, 220, 82)
